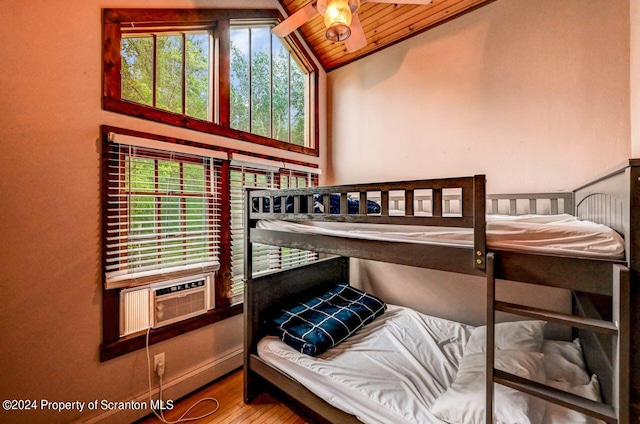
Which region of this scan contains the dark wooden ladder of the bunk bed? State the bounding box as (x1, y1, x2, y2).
(486, 252, 631, 424)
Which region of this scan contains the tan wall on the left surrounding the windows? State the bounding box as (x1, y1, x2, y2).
(0, 0, 326, 423)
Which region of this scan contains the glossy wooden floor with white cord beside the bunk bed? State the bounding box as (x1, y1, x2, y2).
(138, 370, 306, 424)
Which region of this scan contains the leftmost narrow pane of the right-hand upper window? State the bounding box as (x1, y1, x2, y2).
(230, 29, 250, 132)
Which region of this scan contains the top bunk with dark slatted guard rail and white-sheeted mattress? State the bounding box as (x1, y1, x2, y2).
(246, 169, 629, 295)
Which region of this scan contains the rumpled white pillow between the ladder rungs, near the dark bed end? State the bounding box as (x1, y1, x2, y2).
(541, 339, 590, 386)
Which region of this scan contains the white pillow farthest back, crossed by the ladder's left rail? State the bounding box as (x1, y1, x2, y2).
(464, 320, 546, 355)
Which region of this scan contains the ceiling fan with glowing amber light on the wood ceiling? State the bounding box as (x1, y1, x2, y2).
(271, 0, 432, 53)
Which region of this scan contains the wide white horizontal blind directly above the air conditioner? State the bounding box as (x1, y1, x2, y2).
(105, 143, 220, 288)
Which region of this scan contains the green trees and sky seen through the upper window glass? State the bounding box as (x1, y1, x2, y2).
(121, 26, 306, 146)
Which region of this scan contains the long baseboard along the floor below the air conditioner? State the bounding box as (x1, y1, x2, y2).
(80, 346, 243, 424)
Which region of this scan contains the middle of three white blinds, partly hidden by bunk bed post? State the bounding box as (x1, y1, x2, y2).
(230, 163, 278, 303)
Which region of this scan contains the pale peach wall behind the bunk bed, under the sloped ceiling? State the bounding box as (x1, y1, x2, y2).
(328, 0, 637, 324)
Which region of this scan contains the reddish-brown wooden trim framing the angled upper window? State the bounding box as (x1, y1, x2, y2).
(102, 9, 320, 157)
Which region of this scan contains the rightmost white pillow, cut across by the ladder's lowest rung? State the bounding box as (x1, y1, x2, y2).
(543, 374, 603, 424)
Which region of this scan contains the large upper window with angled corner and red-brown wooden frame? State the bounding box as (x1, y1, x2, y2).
(103, 9, 318, 156)
